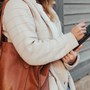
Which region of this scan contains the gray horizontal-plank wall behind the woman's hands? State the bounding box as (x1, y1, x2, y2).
(63, 0, 90, 80)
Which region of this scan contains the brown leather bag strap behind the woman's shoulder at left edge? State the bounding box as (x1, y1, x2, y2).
(0, 0, 8, 46)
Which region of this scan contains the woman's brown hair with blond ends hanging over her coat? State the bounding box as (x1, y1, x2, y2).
(36, 0, 55, 20)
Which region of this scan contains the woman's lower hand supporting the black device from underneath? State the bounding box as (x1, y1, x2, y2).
(62, 45, 82, 65)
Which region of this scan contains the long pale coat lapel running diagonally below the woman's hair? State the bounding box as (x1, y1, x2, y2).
(24, 0, 59, 38)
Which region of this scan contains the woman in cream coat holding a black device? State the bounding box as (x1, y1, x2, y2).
(3, 0, 86, 90)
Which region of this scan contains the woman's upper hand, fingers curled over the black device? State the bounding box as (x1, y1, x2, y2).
(71, 22, 86, 41)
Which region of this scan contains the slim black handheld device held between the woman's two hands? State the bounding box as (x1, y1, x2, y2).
(73, 25, 90, 50)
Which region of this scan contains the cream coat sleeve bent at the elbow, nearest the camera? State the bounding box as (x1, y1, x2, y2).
(3, 0, 78, 65)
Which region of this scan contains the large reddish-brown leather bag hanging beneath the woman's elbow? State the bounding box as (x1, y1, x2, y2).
(0, 0, 50, 90)
